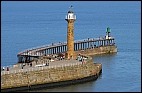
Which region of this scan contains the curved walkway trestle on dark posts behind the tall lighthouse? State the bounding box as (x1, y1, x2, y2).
(17, 37, 115, 63)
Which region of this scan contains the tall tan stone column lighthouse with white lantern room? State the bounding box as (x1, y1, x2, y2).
(65, 6, 76, 59)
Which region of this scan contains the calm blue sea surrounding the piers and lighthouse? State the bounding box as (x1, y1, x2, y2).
(1, 1, 141, 92)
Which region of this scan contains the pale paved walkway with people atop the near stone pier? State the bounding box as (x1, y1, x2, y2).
(1, 54, 88, 76)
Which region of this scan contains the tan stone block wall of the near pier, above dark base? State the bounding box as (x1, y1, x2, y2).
(1, 60, 102, 89)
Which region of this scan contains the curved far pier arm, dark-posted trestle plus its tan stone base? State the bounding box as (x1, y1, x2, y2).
(17, 37, 117, 63)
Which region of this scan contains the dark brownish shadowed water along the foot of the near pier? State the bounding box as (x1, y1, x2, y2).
(24, 74, 101, 92)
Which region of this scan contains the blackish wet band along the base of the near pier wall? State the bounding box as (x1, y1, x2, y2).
(1, 69, 102, 92)
